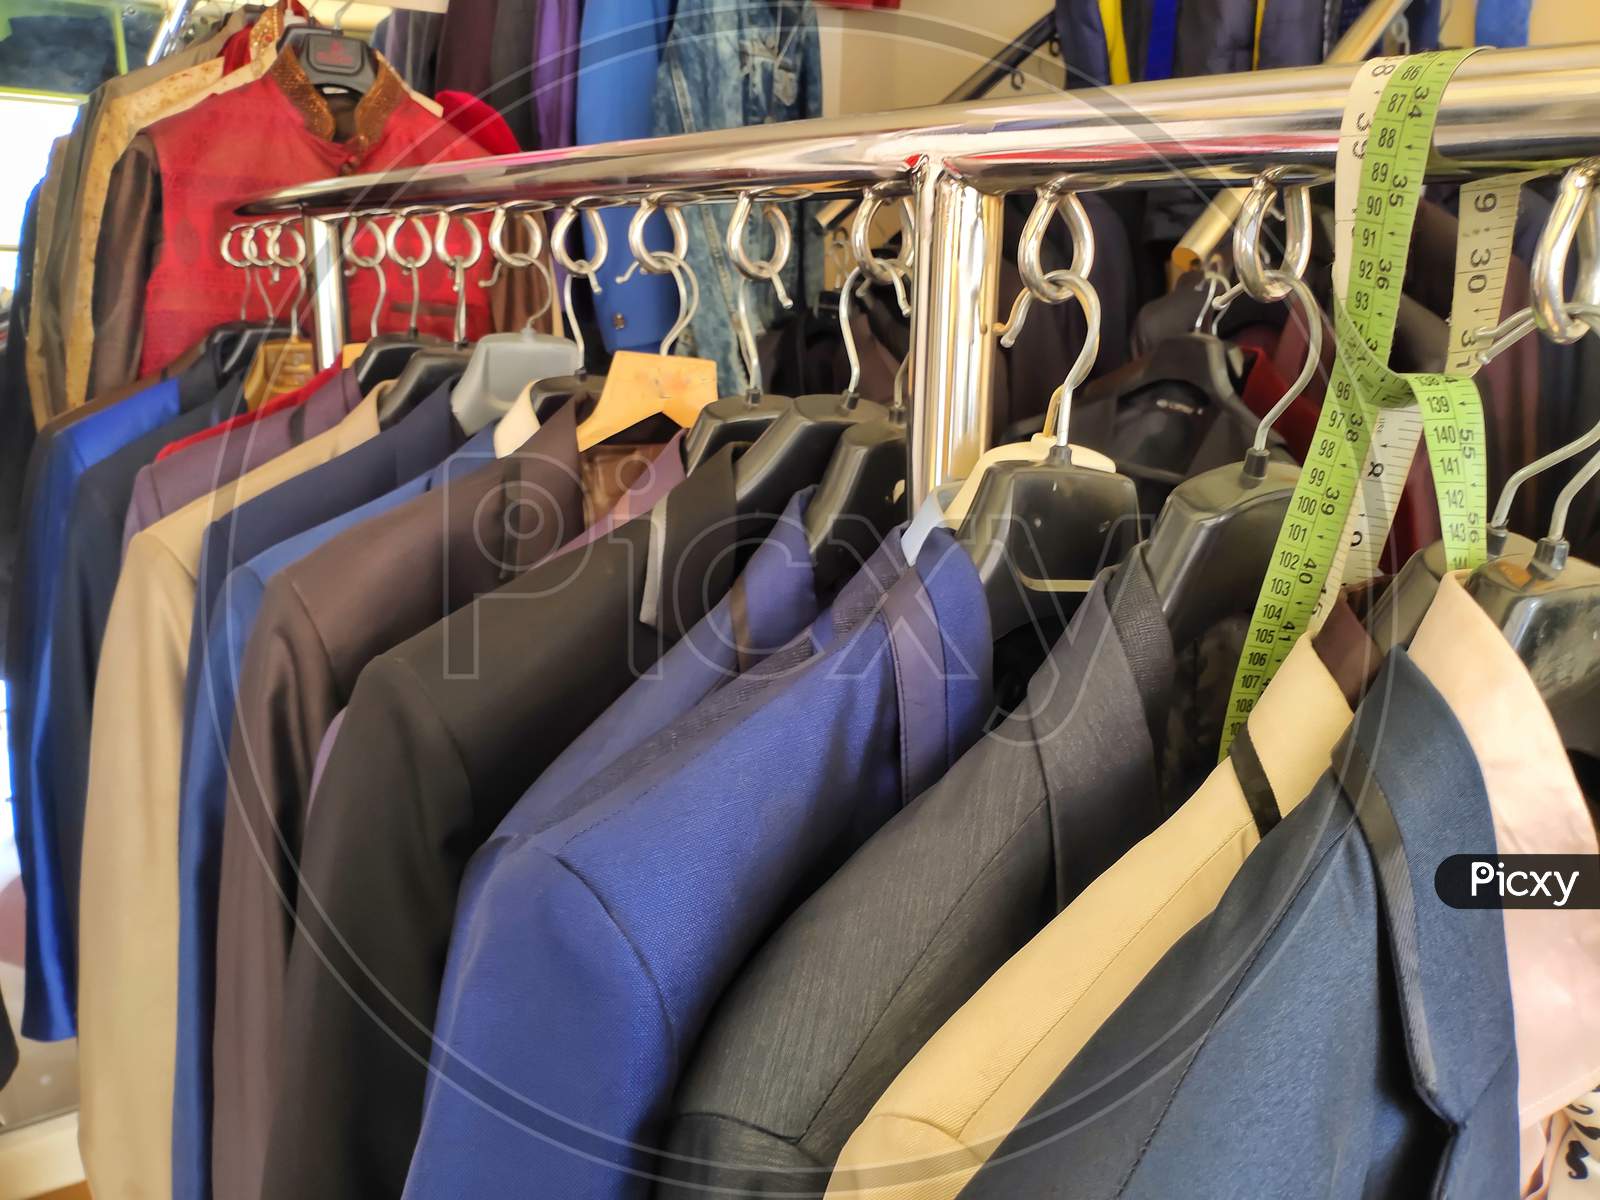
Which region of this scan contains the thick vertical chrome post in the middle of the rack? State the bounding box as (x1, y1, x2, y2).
(906, 158, 1005, 512)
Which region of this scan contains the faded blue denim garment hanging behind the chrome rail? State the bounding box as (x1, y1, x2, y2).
(653, 0, 822, 395)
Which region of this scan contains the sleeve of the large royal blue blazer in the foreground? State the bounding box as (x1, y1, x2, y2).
(406, 844, 674, 1200)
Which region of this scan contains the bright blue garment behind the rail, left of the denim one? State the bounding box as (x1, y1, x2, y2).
(573, 0, 675, 354)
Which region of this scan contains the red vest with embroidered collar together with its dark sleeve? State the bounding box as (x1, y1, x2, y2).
(91, 51, 490, 389)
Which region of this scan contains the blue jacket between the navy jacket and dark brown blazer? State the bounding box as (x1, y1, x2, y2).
(173, 400, 494, 1200)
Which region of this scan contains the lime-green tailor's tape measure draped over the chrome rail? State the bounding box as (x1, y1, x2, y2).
(1221, 51, 1488, 755)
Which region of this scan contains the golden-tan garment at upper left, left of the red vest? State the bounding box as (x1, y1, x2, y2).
(61, 8, 283, 408)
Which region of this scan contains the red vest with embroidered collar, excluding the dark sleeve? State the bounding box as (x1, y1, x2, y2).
(139, 53, 491, 376)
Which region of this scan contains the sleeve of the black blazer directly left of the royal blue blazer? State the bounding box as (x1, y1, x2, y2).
(261, 654, 474, 1200)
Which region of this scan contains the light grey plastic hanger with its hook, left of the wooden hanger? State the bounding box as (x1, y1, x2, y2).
(448, 205, 582, 434)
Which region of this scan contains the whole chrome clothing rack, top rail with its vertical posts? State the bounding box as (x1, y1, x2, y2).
(237, 45, 1600, 506)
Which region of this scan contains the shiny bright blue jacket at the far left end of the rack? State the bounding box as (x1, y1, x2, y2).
(6, 379, 179, 1042)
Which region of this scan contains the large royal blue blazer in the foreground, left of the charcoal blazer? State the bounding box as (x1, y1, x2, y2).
(405, 530, 992, 1200)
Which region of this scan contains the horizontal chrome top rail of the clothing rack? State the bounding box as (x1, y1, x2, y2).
(238, 45, 1600, 214)
